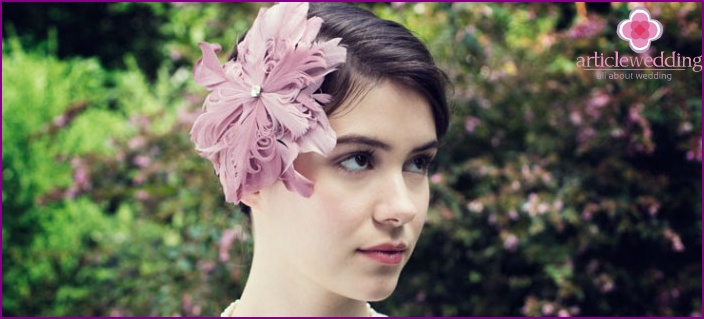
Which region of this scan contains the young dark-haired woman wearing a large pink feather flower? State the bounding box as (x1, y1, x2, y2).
(191, 3, 448, 316)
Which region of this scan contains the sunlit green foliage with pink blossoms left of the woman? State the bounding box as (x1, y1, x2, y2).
(3, 30, 248, 316)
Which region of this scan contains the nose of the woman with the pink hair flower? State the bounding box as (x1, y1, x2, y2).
(373, 172, 418, 227)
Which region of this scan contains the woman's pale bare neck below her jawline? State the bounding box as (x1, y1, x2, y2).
(234, 241, 369, 317)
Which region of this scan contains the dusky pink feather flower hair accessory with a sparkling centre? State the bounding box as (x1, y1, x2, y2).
(191, 3, 347, 204)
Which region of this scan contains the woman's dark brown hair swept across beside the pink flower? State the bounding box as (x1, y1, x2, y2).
(308, 3, 449, 138)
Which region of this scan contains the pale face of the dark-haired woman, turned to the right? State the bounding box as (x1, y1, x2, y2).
(253, 81, 437, 301)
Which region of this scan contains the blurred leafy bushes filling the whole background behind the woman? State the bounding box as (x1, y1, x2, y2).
(2, 3, 702, 316)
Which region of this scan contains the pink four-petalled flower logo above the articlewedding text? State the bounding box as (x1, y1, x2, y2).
(616, 8, 663, 53)
